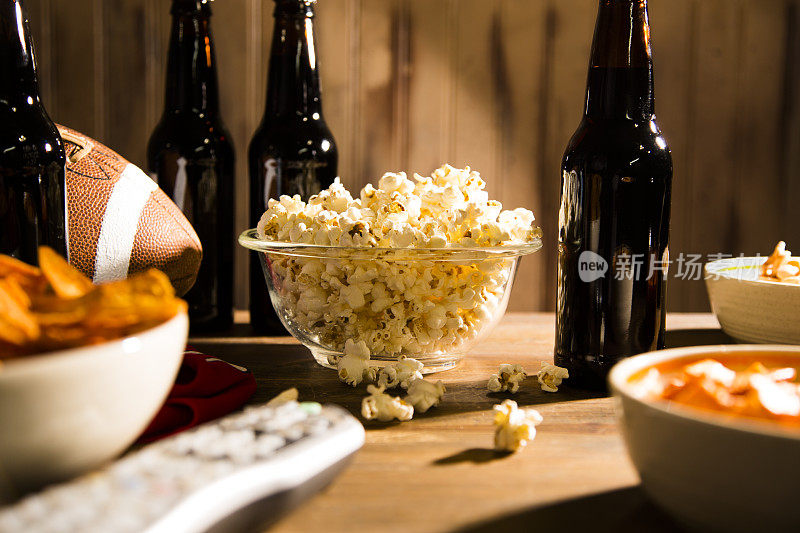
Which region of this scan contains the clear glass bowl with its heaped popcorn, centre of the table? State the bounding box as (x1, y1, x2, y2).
(239, 165, 542, 373)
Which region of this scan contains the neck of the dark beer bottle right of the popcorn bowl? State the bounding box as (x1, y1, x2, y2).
(585, 0, 655, 120)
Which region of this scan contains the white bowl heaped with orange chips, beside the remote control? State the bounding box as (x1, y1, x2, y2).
(0, 248, 188, 496)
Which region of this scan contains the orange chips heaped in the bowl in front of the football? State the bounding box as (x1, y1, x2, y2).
(0, 247, 186, 359)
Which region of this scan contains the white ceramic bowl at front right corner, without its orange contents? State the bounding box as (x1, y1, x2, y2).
(609, 345, 800, 532)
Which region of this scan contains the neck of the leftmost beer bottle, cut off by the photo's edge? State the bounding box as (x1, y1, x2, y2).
(0, 0, 39, 98)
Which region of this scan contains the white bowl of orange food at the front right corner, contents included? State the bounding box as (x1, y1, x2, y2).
(609, 345, 800, 531)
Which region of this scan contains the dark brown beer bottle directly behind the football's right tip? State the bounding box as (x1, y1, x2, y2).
(147, 0, 236, 331)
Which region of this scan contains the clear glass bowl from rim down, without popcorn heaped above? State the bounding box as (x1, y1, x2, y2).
(239, 229, 542, 373)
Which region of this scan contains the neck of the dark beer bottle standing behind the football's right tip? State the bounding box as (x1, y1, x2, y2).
(165, 0, 219, 115)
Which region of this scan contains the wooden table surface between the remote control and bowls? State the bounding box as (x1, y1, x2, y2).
(190, 313, 730, 533)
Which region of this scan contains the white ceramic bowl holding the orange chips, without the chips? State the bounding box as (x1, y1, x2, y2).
(0, 314, 189, 496)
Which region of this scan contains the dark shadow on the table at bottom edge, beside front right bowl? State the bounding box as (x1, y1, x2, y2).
(457, 487, 685, 533)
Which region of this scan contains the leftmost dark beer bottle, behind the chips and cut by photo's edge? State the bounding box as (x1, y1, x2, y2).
(0, 0, 67, 264)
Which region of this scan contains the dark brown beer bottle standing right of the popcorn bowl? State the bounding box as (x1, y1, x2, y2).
(555, 0, 672, 388)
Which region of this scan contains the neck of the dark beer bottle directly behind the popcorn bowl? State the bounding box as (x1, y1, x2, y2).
(265, 0, 322, 118)
